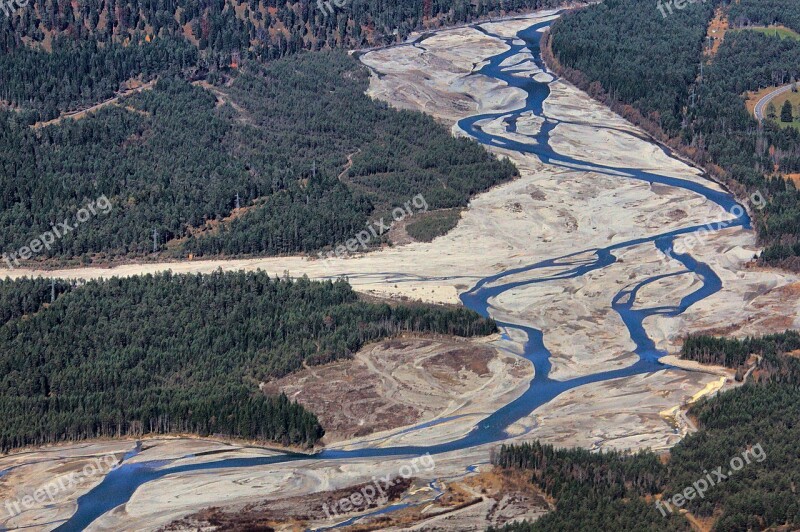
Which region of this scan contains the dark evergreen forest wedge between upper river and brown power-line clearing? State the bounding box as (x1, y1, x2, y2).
(551, 0, 713, 135)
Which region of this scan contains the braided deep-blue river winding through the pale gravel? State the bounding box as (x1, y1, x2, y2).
(57, 17, 750, 531)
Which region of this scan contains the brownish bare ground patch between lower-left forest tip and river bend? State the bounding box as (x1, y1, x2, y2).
(261, 338, 526, 444)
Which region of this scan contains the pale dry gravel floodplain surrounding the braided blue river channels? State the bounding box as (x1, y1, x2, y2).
(0, 8, 800, 530)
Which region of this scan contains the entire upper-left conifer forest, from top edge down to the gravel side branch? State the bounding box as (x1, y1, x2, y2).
(0, 0, 572, 266)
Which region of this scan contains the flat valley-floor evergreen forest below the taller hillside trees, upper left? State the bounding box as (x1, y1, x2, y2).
(0, 51, 517, 261)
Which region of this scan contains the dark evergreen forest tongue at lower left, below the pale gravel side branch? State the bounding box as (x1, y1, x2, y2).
(0, 272, 496, 451)
